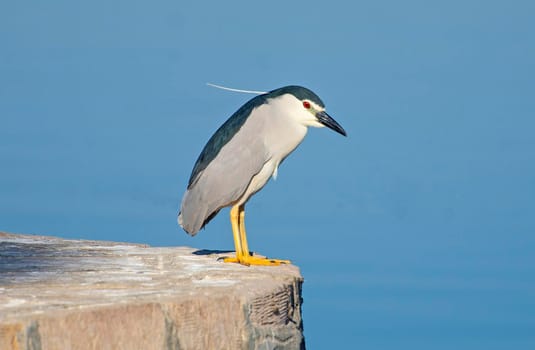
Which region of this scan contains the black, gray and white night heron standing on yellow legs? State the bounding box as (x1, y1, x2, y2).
(178, 85, 347, 266)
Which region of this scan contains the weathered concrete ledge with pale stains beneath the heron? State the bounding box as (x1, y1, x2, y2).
(0, 232, 304, 349)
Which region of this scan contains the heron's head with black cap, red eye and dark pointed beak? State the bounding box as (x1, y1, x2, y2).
(265, 85, 347, 136)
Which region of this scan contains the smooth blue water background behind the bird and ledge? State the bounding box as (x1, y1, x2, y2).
(0, 0, 535, 349)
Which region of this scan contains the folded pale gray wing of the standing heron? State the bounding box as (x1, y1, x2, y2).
(178, 104, 270, 235)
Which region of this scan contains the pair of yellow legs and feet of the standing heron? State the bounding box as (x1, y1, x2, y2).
(224, 205, 290, 266)
